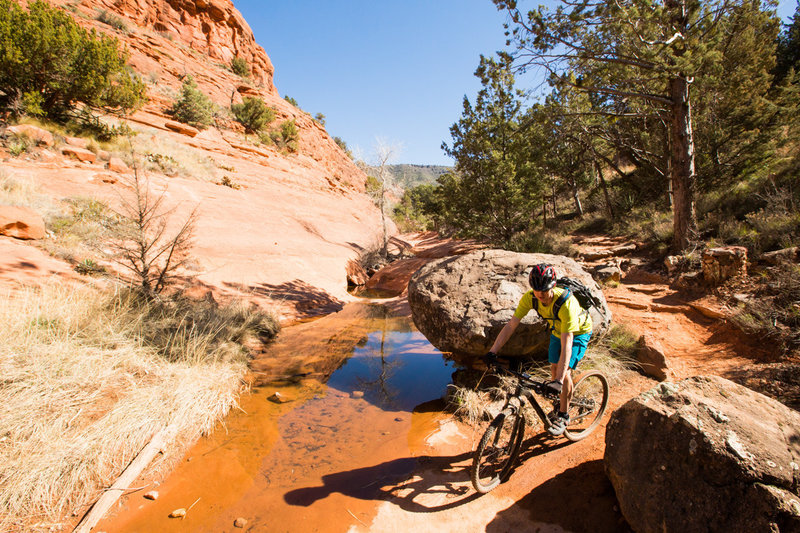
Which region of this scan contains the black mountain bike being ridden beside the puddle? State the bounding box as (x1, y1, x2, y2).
(470, 367, 609, 494)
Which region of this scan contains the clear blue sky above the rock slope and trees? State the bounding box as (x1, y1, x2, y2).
(234, 0, 797, 165)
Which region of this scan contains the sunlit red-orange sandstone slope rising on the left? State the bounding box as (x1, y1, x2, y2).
(5, 0, 388, 319)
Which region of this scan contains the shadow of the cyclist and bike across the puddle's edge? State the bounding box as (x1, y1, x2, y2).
(284, 432, 569, 513)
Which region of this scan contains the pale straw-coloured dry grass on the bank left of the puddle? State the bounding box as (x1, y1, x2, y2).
(0, 286, 278, 531)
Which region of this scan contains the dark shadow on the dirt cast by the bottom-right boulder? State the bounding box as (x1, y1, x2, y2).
(486, 459, 631, 533)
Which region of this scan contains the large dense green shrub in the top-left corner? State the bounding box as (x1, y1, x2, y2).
(0, 0, 146, 119)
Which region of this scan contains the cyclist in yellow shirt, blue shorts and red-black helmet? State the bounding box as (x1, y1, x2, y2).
(485, 263, 592, 436)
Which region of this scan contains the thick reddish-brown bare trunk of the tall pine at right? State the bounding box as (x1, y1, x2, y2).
(670, 76, 697, 252)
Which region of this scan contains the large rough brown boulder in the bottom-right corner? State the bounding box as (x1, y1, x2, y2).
(605, 376, 800, 533)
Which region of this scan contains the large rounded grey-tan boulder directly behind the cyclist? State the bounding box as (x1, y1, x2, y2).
(408, 250, 611, 356)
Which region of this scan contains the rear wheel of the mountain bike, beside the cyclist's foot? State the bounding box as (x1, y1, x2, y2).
(564, 370, 609, 442)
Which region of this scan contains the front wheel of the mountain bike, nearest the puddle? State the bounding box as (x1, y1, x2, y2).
(470, 408, 525, 494)
